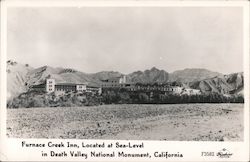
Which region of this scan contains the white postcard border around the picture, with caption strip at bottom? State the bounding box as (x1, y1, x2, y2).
(0, 0, 250, 161)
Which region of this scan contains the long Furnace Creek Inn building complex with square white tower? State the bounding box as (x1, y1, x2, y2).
(30, 75, 201, 95)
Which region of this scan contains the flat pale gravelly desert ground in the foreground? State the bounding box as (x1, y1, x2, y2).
(7, 104, 244, 141)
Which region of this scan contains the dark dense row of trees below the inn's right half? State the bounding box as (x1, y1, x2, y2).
(102, 89, 244, 104)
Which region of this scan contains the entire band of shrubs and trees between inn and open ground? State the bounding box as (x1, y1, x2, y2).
(7, 88, 244, 108)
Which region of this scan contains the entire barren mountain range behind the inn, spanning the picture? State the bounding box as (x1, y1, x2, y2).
(7, 60, 244, 98)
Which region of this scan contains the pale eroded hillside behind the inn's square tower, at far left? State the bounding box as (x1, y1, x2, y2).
(7, 61, 100, 99)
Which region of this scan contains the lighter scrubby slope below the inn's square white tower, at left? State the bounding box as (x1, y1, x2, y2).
(7, 91, 101, 108)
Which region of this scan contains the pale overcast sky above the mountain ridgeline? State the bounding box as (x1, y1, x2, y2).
(7, 7, 243, 74)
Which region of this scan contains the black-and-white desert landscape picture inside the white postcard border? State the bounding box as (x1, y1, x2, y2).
(7, 4, 244, 141)
